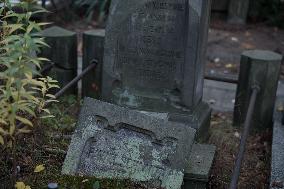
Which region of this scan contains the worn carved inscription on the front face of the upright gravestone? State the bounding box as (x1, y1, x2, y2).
(115, 0, 185, 90)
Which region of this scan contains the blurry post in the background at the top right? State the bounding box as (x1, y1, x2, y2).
(228, 0, 249, 24)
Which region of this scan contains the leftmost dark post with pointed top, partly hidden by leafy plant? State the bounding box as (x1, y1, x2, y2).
(37, 26, 78, 94)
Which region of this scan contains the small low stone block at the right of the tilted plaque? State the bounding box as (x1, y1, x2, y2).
(181, 144, 216, 189)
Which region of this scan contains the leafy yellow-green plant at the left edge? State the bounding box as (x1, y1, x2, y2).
(0, 0, 58, 185)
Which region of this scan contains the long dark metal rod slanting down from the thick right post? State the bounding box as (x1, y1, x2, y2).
(230, 86, 260, 189)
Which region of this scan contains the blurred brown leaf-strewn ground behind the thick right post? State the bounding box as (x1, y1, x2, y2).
(206, 22, 284, 79)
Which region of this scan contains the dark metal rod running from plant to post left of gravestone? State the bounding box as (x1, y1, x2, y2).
(54, 60, 98, 98)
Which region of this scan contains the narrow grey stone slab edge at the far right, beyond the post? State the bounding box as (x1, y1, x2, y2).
(270, 97, 284, 189)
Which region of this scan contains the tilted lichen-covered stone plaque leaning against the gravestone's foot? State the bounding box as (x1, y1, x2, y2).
(62, 98, 195, 189)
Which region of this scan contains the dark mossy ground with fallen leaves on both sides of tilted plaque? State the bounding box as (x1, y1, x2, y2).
(0, 96, 271, 189)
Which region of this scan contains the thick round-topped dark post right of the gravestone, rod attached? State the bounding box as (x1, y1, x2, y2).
(234, 50, 282, 129)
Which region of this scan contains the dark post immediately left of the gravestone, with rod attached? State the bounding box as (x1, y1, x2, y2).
(82, 29, 105, 98)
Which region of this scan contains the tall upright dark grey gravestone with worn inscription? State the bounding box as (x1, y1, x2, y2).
(102, 0, 211, 139)
